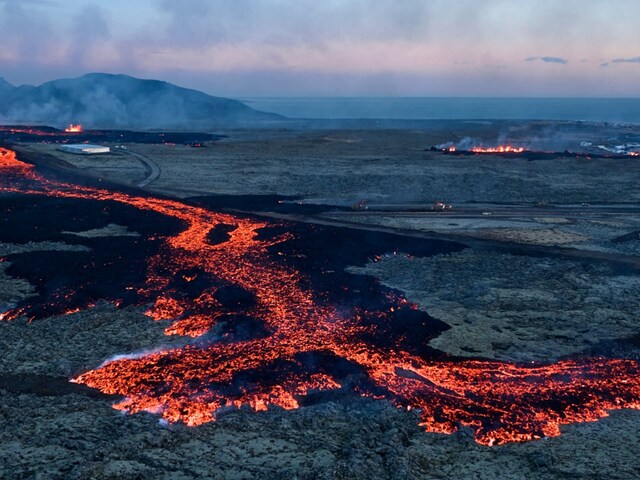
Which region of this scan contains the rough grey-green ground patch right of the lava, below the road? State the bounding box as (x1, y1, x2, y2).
(350, 250, 640, 362)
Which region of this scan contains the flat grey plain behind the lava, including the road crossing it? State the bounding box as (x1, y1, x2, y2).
(23, 122, 640, 255)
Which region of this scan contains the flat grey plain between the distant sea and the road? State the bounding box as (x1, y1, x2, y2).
(22, 122, 640, 205)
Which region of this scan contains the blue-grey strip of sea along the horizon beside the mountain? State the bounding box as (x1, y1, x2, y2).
(240, 97, 640, 123)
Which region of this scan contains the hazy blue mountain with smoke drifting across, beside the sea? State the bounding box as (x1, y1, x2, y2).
(0, 73, 283, 130)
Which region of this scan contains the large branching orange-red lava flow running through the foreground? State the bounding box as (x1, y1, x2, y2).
(0, 150, 640, 445)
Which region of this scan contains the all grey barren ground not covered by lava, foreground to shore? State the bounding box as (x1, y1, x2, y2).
(0, 122, 640, 479)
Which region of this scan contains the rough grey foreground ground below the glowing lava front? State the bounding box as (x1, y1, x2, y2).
(0, 376, 640, 480)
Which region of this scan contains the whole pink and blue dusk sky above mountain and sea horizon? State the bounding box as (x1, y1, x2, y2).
(0, 0, 640, 97)
